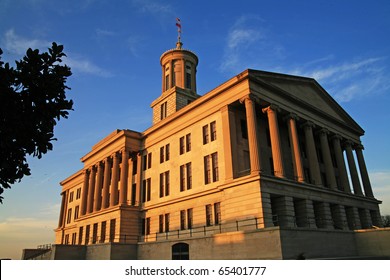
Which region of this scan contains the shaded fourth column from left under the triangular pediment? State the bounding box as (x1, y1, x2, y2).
(303, 122, 322, 185)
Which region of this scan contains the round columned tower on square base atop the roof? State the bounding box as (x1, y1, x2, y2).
(151, 37, 199, 124)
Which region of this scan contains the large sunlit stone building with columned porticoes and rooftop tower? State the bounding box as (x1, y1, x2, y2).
(27, 38, 387, 259)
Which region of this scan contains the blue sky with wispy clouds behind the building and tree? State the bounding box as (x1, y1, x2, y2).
(0, 0, 390, 259)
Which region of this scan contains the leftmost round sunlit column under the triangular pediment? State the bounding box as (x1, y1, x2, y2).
(240, 95, 260, 174)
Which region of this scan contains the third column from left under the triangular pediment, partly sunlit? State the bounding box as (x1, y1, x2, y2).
(286, 114, 305, 182)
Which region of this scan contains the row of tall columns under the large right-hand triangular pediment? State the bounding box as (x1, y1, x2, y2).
(240, 95, 373, 197)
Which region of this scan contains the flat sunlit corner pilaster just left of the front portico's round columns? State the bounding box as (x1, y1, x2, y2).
(221, 105, 238, 180)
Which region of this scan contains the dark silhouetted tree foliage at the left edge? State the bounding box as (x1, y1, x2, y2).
(0, 43, 73, 203)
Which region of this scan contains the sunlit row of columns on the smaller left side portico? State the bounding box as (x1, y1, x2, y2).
(81, 149, 133, 215)
